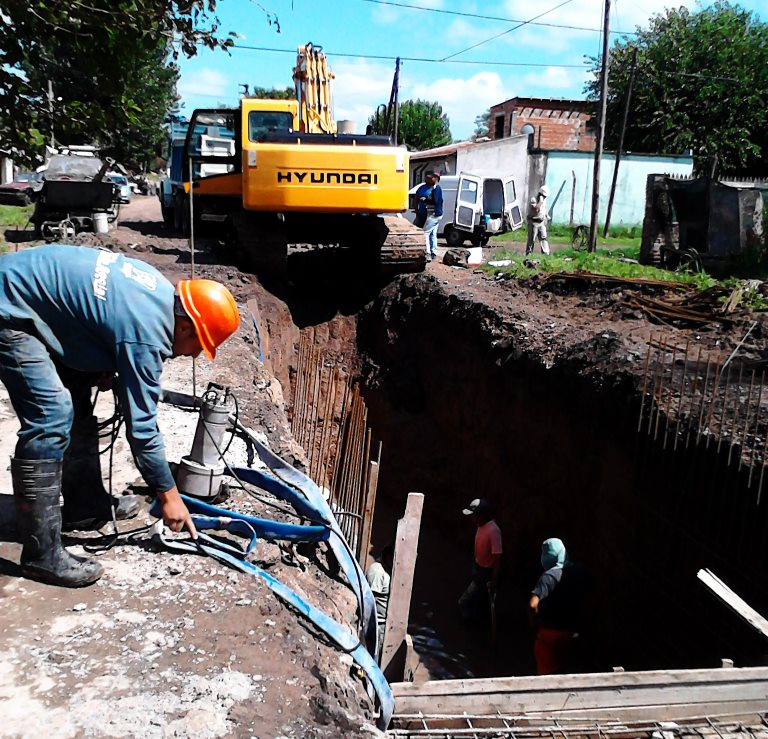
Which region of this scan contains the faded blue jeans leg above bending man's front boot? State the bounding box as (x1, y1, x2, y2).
(0, 322, 74, 459)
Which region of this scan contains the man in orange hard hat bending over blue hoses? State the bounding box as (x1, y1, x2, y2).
(0, 245, 240, 587)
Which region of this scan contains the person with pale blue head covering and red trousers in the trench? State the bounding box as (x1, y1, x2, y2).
(528, 538, 592, 675)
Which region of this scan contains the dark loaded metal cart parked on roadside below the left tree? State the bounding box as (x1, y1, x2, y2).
(30, 153, 119, 242)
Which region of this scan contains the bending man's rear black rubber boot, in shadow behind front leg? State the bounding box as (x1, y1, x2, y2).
(61, 416, 141, 531)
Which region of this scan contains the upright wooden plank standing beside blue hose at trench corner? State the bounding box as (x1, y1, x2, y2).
(381, 493, 424, 679)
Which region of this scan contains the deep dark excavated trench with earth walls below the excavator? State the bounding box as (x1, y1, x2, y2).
(271, 276, 768, 677)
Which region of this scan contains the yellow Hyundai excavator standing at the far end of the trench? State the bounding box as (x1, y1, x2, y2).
(178, 44, 425, 273)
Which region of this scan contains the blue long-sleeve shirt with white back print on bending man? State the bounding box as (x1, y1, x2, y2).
(0, 245, 175, 491)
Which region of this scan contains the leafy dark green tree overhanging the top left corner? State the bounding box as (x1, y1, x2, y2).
(0, 0, 277, 165)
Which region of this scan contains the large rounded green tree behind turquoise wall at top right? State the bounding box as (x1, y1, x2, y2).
(587, 1, 768, 173)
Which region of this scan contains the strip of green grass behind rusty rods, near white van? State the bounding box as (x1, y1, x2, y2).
(481, 246, 716, 290)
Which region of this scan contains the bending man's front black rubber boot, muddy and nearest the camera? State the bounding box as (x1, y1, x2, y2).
(11, 459, 103, 588)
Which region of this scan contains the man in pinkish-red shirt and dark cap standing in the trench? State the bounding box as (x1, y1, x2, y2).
(459, 498, 503, 621)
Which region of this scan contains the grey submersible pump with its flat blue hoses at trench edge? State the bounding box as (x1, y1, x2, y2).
(158, 384, 394, 729)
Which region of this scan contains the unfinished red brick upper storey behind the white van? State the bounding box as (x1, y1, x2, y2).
(489, 97, 595, 151)
